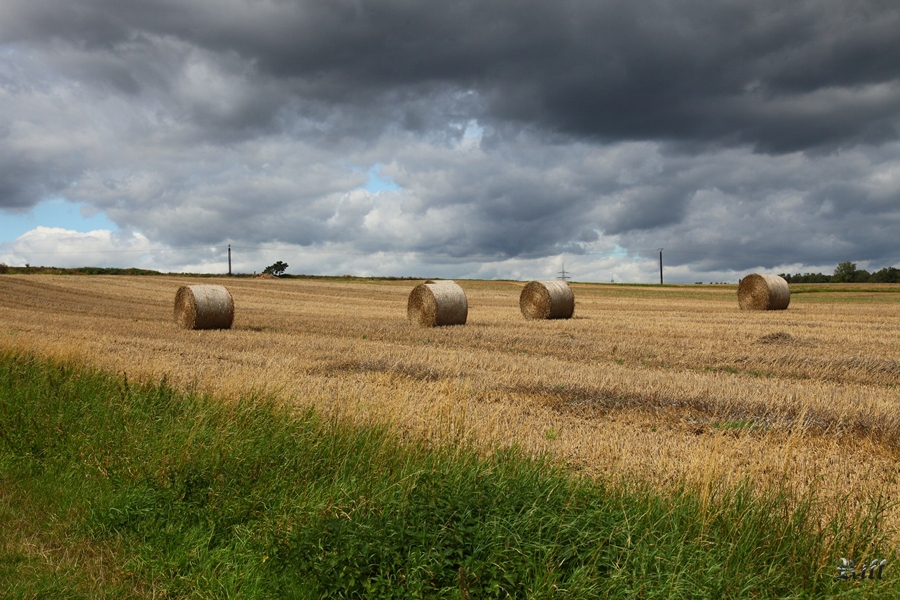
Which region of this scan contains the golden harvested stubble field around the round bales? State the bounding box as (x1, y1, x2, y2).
(0, 275, 900, 531)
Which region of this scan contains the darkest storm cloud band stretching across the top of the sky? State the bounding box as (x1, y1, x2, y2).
(5, 0, 900, 152)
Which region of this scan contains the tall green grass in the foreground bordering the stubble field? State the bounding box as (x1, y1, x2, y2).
(0, 354, 900, 599)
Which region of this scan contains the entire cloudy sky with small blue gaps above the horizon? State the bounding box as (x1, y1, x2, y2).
(0, 0, 900, 283)
